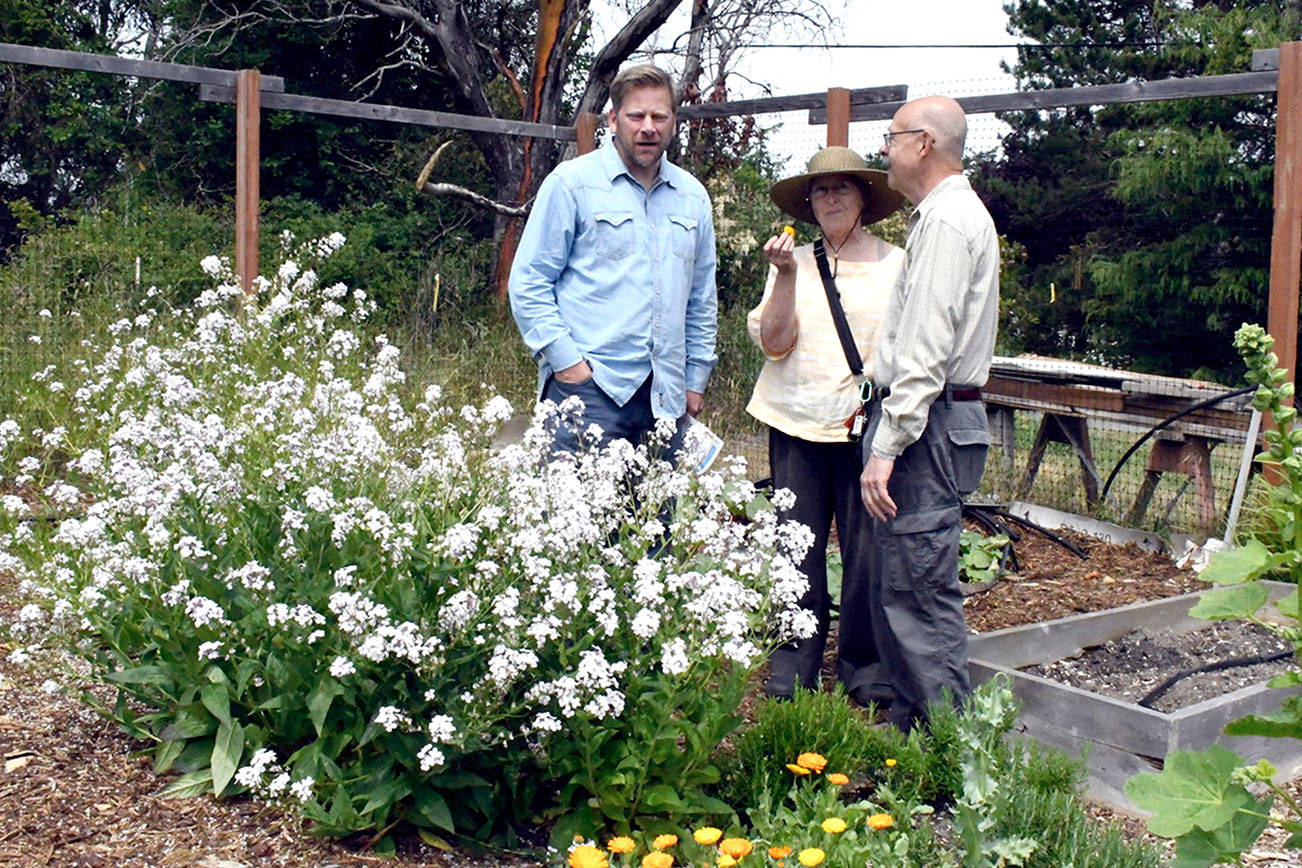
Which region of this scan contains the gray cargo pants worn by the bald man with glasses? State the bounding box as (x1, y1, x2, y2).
(863, 389, 990, 731)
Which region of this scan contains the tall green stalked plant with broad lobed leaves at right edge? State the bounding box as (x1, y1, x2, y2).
(1126, 324, 1302, 867)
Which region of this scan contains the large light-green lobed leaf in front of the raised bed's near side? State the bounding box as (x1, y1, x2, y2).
(1125, 744, 1253, 838)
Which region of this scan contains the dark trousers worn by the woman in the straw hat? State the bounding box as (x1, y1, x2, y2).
(764, 428, 889, 704)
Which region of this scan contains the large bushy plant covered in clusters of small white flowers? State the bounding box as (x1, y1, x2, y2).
(0, 236, 812, 842)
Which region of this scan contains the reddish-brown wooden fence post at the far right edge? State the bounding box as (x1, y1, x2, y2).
(1266, 42, 1302, 390)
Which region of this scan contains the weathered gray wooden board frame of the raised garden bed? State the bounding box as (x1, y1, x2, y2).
(969, 582, 1302, 811)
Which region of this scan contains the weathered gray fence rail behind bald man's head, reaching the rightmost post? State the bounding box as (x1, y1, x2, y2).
(810, 70, 1279, 124)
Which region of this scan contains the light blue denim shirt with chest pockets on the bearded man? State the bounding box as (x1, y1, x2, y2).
(510, 146, 719, 418)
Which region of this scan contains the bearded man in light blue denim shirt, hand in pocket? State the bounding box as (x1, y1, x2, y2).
(510, 64, 717, 452)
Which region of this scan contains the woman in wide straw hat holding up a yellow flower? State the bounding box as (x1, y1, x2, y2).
(746, 147, 904, 704)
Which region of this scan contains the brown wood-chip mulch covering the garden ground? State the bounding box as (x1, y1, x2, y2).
(0, 532, 1293, 868)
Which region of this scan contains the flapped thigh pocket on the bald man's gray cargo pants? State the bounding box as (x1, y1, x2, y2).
(885, 505, 962, 595)
